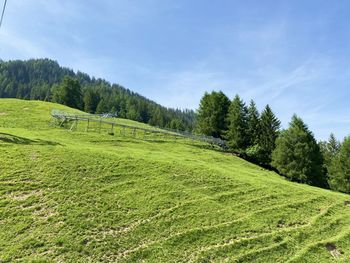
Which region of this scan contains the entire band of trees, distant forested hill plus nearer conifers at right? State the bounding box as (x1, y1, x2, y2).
(0, 59, 350, 193)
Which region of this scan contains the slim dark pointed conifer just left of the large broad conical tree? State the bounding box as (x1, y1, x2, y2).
(259, 105, 281, 165)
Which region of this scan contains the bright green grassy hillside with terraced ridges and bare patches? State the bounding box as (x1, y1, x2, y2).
(0, 99, 350, 262)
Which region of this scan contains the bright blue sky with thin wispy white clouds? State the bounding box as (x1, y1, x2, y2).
(0, 0, 350, 140)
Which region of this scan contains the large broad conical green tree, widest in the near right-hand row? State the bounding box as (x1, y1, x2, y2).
(272, 115, 326, 187)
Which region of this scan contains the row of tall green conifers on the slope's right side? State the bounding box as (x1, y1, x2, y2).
(196, 91, 350, 193)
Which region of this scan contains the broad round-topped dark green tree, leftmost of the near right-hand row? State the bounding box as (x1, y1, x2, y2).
(197, 91, 230, 138)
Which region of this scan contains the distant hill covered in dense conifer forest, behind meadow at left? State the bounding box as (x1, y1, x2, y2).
(0, 59, 195, 130)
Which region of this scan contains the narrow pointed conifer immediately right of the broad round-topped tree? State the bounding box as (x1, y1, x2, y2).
(226, 95, 249, 153)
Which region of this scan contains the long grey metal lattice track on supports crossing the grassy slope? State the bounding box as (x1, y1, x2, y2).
(51, 109, 226, 149)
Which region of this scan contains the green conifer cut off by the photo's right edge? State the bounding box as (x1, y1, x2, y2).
(328, 136, 350, 193)
